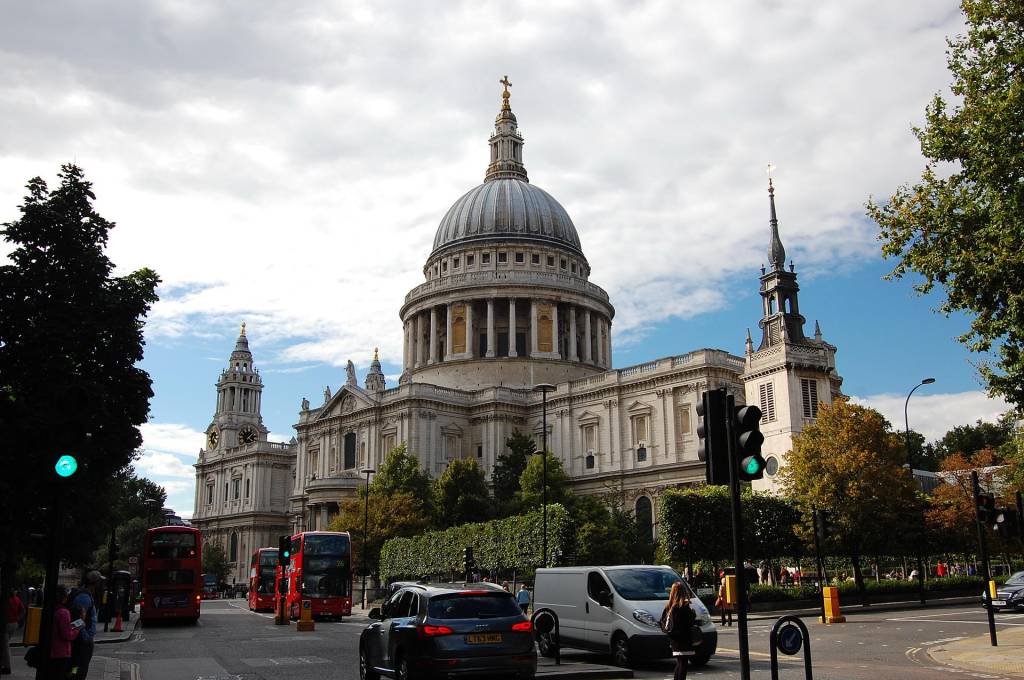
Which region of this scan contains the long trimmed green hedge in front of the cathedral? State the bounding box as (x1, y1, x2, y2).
(380, 504, 574, 582)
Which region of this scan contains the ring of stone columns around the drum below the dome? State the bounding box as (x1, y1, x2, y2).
(402, 298, 611, 370)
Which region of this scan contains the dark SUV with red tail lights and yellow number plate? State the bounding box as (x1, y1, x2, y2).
(359, 584, 537, 680)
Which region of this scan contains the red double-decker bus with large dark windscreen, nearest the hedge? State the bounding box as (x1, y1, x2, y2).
(286, 532, 352, 620)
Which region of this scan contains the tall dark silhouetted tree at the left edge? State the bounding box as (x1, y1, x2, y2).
(0, 165, 159, 586)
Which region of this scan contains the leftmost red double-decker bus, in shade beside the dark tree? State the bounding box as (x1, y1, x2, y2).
(139, 526, 203, 622)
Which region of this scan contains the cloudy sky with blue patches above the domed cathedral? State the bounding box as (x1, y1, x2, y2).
(0, 0, 1005, 516)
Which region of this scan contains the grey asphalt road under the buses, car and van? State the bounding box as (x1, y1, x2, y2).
(121, 600, 1024, 680)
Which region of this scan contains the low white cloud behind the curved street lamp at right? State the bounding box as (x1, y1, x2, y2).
(851, 390, 1010, 441)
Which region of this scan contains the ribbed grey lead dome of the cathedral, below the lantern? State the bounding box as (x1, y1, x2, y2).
(433, 177, 583, 255)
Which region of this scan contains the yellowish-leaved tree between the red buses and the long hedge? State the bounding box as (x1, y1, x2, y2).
(330, 485, 430, 573)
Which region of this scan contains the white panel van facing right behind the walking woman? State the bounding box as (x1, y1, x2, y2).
(534, 564, 718, 667)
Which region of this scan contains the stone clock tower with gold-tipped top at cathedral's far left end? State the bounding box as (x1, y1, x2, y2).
(191, 324, 295, 584)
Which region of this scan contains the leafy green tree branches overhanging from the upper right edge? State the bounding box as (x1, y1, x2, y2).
(867, 0, 1024, 408)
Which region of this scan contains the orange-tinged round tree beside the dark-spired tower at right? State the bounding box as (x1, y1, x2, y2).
(781, 398, 924, 593)
